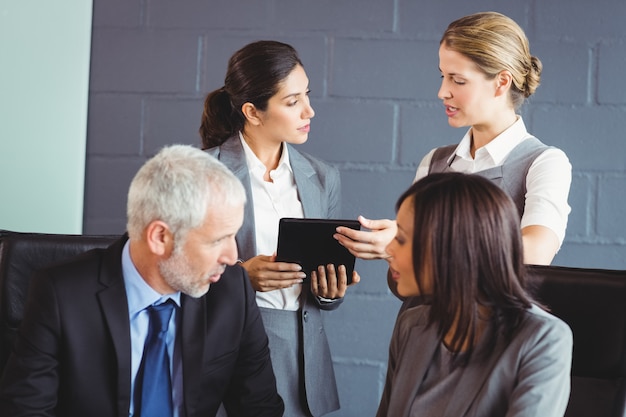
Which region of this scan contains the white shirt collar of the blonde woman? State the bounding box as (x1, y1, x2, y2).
(448, 116, 530, 165)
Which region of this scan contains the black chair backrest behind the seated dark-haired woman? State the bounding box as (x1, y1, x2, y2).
(529, 266, 626, 417)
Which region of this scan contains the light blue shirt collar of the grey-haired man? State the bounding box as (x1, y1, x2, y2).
(122, 240, 180, 318)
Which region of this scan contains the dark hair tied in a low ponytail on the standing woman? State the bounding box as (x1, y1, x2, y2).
(199, 41, 302, 149)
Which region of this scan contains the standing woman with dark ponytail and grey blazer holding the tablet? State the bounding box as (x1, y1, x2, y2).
(200, 41, 359, 417)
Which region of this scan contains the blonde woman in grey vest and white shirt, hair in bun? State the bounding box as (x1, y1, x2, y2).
(336, 12, 571, 265)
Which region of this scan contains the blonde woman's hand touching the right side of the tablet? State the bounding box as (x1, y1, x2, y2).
(334, 216, 396, 259)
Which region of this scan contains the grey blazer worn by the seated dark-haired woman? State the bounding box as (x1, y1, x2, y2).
(376, 305, 573, 417)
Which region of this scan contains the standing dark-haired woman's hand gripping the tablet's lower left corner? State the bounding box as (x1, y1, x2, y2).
(241, 255, 306, 292)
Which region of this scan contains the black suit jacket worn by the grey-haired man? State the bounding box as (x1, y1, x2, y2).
(0, 238, 283, 417)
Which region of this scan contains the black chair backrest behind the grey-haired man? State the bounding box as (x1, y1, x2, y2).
(0, 230, 119, 375)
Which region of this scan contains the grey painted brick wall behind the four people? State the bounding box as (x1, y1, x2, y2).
(84, 0, 626, 417)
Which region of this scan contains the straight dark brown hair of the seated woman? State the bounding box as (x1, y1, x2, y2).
(396, 173, 532, 363)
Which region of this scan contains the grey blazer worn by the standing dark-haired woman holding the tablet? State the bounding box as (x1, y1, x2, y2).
(207, 134, 343, 416)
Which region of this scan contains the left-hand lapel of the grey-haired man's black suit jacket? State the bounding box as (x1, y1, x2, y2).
(97, 236, 131, 415)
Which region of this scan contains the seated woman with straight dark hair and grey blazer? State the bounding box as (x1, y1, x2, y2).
(377, 173, 573, 417)
